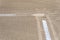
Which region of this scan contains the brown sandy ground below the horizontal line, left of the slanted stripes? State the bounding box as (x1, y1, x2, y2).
(0, 16, 43, 40)
